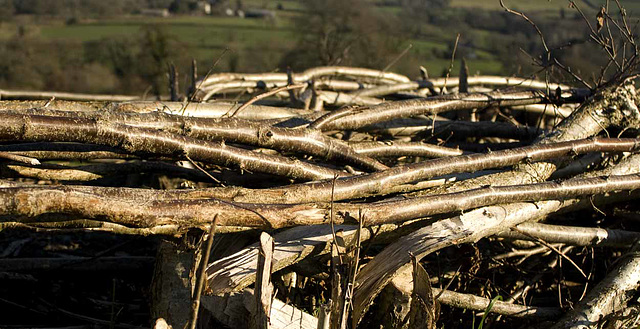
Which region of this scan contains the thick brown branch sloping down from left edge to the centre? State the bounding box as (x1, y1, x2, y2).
(0, 113, 344, 180)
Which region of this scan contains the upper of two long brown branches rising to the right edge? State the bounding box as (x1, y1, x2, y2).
(234, 138, 640, 203)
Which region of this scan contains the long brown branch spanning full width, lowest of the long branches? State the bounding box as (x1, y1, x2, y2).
(0, 174, 640, 229)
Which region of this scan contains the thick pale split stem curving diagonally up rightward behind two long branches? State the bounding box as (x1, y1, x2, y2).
(353, 83, 640, 324)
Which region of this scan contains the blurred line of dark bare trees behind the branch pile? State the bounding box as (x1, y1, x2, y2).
(0, 0, 624, 95)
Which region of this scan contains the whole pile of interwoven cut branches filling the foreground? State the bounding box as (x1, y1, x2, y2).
(0, 67, 640, 328)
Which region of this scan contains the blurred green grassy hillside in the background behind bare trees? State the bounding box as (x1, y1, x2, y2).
(0, 0, 640, 95)
